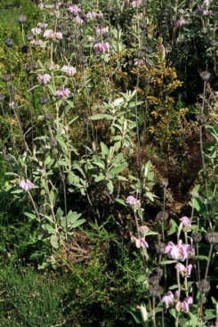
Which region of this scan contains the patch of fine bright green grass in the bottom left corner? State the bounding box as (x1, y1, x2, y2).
(0, 266, 69, 327)
